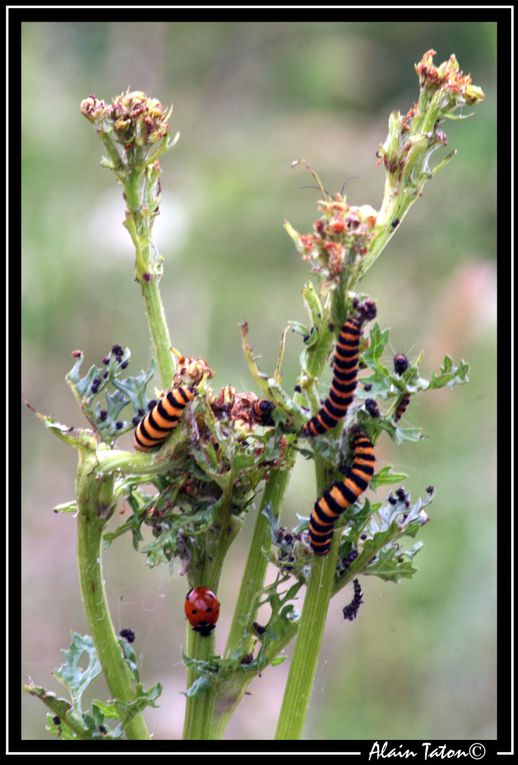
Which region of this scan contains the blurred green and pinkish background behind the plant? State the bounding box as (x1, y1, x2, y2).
(22, 21, 496, 739)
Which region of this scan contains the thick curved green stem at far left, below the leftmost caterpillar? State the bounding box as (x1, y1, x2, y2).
(76, 453, 149, 740)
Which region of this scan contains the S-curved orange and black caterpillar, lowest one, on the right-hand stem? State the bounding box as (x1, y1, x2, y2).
(309, 432, 375, 555)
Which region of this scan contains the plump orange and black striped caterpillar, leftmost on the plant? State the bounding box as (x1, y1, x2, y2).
(133, 386, 196, 452)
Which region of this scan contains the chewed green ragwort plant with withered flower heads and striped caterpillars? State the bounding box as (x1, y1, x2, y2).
(24, 51, 484, 740)
